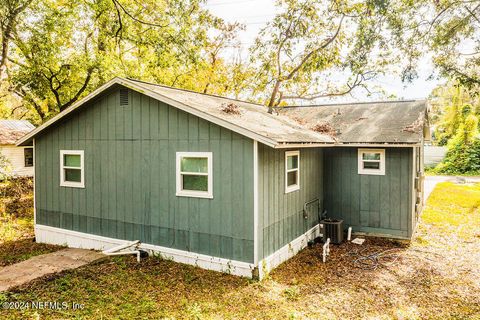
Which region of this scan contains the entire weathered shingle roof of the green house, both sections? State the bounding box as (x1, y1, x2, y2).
(17, 78, 427, 147)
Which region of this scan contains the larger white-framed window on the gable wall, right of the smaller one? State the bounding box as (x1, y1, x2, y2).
(177, 152, 213, 198)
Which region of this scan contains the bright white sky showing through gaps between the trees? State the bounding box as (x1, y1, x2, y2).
(206, 0, 440, 100)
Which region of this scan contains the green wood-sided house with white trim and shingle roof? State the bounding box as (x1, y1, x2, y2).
(17, 78, 428, 278)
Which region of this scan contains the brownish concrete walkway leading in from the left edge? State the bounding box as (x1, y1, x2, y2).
(0, 248, 106, 292)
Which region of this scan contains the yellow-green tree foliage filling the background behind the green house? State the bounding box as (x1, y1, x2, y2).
(0, 0, 480, 173)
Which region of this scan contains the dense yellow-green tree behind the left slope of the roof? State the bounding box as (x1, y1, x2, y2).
(0, 0, 229, 122)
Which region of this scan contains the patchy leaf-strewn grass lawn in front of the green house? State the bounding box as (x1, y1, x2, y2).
(0, 183, 480, 319)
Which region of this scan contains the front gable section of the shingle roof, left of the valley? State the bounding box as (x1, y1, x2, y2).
(17, 77, 335, 147)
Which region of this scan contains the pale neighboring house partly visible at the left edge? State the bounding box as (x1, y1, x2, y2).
(0, 120, 35, 177)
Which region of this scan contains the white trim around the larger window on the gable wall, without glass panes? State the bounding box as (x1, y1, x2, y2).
(176, 152, 213, 199)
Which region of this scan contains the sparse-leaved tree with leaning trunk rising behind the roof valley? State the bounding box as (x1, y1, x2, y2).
(251, 0, 391, 112)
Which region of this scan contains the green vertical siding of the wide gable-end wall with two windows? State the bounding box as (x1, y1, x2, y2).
(35, 88, 254, 262)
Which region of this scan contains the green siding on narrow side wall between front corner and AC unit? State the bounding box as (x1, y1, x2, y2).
(257, 144, 323, 260)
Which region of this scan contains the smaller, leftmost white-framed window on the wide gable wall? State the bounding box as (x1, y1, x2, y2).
(60, 150, 85, 188)
